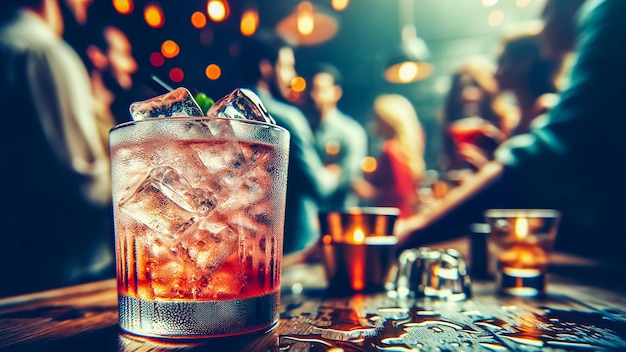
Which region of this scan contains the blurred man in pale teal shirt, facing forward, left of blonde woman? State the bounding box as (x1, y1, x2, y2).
(308, 63, 368, 210)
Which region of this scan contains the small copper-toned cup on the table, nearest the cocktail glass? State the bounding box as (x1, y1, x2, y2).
(319, 207, 399, 294)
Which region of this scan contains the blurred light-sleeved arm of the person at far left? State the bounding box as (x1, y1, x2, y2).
(26, 42, 111, 205)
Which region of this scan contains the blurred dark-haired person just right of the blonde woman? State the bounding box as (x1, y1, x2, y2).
(438, 58, 514, 177)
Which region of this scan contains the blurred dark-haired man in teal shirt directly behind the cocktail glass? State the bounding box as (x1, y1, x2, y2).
(240, 29, 340, 254)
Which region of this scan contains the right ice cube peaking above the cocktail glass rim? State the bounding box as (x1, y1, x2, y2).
(207, 88, 276, 124)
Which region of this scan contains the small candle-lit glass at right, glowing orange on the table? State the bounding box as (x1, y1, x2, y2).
(485, 209, 561, 297)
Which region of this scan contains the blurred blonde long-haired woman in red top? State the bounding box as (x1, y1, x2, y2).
(354, 94, 425, 217)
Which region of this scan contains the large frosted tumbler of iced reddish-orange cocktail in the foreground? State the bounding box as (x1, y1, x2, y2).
(110, 117, 289, 339)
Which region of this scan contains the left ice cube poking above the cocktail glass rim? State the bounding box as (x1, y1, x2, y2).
(129, 87, 204, 121)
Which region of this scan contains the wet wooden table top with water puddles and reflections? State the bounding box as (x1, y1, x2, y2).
(0, 238, 626, 352)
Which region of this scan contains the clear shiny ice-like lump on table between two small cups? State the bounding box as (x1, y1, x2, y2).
(395, 247, 471, 301)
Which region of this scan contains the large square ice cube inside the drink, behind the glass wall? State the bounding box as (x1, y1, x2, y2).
(119, 166, 215, 237)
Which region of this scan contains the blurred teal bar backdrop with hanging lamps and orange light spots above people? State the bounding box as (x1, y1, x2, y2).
(86, 0, 545, 169)
